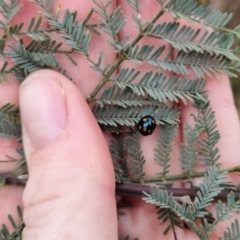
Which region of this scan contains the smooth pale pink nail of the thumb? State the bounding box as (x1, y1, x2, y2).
(20, 75, 67, 150)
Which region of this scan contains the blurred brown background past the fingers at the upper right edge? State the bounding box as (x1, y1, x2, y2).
(198, 0, 240, 116)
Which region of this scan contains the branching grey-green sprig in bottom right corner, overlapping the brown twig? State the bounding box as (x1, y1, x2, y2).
(143, 184, 240, 239)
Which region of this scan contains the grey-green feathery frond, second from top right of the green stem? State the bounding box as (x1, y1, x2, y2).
(147, 22, 239, 61)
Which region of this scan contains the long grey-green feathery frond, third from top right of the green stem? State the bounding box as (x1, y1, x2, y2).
(127, 45, 239, 78)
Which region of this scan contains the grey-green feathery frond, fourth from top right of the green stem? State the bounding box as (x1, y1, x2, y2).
(113, 69, 205, 103)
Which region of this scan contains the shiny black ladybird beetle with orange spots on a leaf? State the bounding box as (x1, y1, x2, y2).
(137, 115, 156, 136)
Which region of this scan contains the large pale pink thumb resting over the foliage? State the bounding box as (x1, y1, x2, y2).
(20, 70, 117, 240)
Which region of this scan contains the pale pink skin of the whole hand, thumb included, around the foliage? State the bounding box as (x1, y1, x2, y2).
(0, 0, 240, 240)
